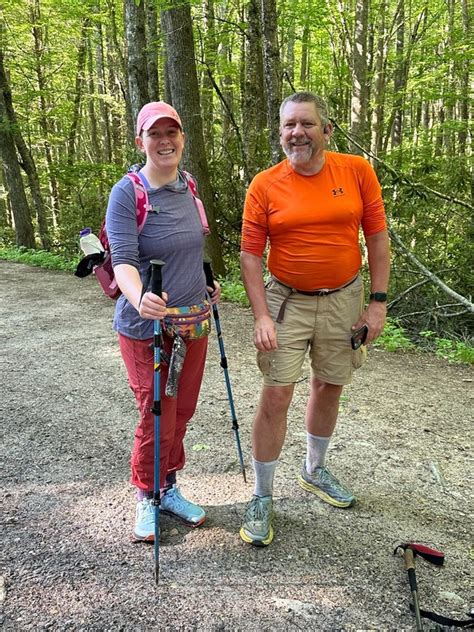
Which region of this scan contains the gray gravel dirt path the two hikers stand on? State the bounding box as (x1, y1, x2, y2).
(0, 262, 474, 632)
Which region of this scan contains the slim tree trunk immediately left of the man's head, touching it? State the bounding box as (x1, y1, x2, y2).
(261, 0, 282, 164)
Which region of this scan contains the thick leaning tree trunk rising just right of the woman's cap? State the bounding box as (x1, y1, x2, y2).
(161, 0, 225, 276)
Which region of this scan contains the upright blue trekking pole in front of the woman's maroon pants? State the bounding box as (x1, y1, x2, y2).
(150, 259, 165, 584)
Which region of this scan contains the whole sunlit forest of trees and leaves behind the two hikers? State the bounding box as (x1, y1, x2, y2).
(0, 0, 474, 358)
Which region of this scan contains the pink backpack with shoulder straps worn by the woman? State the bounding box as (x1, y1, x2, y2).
(74, 170, 210, 301)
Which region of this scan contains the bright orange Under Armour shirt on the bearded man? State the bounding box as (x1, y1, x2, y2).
(241, 152, 387, 291)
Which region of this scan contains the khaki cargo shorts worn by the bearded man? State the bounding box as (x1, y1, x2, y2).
(257, 275, 366, 386)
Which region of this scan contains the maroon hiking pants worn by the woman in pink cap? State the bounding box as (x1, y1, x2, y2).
(119, 334, 207, 491)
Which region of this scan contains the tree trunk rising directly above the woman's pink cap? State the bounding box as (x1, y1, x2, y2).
(125, 0, 150, 127)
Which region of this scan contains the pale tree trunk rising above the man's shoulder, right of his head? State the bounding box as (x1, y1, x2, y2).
(351, 0, 369, 153)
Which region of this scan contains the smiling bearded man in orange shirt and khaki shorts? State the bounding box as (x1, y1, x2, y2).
(240, 92, 390, 546)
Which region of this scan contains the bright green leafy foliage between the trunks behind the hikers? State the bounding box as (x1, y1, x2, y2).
(0, 0, 474, 346)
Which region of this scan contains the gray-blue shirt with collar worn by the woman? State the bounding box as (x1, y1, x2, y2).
(106, 173, 206, 340)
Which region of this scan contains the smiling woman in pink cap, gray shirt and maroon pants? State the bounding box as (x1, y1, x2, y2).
(106, 102, 220, 542)
